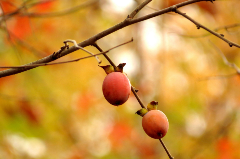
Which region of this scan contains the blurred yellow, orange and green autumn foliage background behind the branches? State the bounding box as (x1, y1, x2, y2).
(0, 0, 240, 159)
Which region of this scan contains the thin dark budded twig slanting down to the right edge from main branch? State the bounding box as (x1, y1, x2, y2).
(173, 8, 240, 48)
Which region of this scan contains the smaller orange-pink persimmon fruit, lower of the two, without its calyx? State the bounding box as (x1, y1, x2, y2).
(142, 110, 169, 139)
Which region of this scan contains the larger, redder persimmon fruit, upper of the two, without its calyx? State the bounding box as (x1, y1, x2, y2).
(102, 72, 131, 106)
